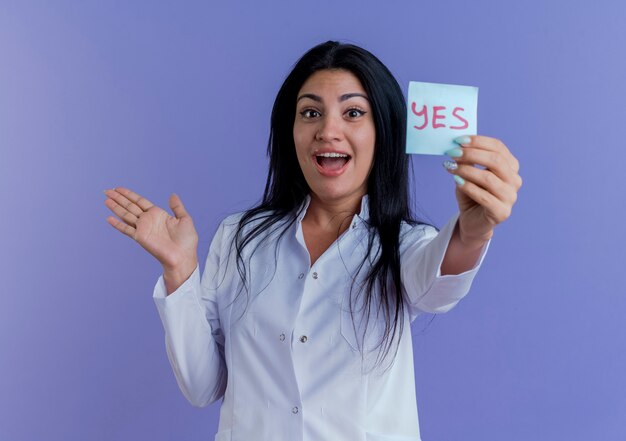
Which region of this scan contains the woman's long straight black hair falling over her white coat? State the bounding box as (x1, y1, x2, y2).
(234, 41, 432, 370)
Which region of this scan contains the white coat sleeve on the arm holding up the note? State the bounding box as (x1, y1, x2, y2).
(401, 212, 491, 319)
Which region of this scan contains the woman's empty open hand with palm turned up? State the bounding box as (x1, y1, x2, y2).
(104, 187, 198, 276)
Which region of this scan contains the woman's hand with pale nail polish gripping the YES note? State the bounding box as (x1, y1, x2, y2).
(444, 135, 522, 244)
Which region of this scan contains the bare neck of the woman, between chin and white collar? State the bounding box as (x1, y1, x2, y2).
(303, 192, 363, 234)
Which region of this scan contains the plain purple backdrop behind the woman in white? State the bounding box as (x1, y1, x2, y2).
(0, 0, 626, 441)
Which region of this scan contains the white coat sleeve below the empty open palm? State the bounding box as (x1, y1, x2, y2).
(153, 222, 227, 407)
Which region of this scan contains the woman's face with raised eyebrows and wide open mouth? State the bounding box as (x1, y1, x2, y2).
(293, 69, 376, 202)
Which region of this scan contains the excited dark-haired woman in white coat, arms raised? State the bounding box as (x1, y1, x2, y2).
(105, 41, 522, 441)
